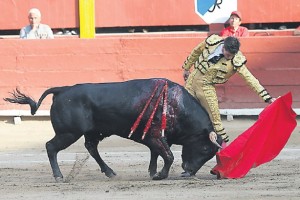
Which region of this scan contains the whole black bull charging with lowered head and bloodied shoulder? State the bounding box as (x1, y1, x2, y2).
(4, 79, 221, 181)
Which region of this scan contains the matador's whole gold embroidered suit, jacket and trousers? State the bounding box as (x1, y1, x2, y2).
(182, 35, 271, 142)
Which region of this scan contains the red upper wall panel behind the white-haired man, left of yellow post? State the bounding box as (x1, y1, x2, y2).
(0, 0, 79, 30)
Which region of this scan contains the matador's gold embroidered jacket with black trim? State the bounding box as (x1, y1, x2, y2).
(182, 35, 271, 102)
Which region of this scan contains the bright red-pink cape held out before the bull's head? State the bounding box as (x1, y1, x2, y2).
(212, 93, 297, 178)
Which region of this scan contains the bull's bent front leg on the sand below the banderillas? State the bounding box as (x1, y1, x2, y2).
(149, 138, 174, 180)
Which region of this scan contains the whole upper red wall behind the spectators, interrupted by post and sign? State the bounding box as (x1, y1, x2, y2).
(0, 0, 300, 30)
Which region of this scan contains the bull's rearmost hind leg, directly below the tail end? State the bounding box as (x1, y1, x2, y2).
(46, 134, 80, 182)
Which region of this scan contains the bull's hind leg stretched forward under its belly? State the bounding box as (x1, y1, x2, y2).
(84, 135, 117, 178)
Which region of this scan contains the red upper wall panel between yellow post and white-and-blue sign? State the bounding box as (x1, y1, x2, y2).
(95, 0, 205, 27)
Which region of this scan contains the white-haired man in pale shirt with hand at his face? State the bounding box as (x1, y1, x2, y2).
(20, 8, 54, 39)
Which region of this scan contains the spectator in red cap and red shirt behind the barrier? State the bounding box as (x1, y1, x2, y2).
(220, 11, 249, 37)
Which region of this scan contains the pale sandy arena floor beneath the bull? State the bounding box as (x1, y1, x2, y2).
(0, 117, 300, 200)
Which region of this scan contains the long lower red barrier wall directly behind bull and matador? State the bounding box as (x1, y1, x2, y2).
(0, 33, 300, 110)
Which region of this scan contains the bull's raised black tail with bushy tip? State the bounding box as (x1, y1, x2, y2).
(3, 87, 64, 115)
